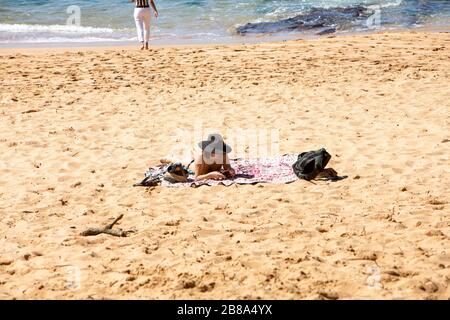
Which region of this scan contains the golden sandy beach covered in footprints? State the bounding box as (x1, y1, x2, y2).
(0, 32, 450, 299)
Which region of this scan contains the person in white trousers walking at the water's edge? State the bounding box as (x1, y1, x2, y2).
(130, 0, 158, 50)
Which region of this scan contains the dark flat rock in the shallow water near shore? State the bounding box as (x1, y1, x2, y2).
(236, 6, 371, 35)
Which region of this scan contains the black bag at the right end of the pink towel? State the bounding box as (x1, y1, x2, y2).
(292, 148, 331, 180)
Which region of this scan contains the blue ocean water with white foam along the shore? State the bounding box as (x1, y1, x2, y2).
(0, 0, 450, 45)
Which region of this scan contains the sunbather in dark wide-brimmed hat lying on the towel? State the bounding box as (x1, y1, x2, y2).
(194, 134, 235, 180)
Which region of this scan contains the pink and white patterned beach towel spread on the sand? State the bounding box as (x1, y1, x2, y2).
(137, 154, 298, 188)
